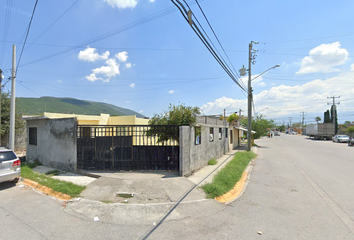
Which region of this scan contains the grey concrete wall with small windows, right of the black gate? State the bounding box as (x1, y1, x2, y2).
(179, 116, 230, 176)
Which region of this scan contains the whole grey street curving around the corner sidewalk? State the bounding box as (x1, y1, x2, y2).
(0, 134, 354, 239)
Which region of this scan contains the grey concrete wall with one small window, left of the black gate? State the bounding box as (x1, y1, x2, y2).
(27, 118, 77, 172)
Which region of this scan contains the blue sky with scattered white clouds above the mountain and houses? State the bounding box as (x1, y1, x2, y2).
(0, 0, 354, 124)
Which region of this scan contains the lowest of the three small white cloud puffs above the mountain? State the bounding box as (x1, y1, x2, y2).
(85, 58, 120, 82)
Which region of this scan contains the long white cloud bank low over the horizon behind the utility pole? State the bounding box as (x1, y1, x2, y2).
(201, 69, 354, 121)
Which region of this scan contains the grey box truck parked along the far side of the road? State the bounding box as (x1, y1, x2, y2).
(306, 123, 335, 140)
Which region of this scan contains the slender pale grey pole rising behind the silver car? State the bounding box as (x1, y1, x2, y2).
(9, 45, 16, 150)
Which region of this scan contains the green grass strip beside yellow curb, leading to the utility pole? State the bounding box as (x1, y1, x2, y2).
(202, 152, 256, 198)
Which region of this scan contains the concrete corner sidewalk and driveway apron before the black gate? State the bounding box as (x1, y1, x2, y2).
(27, 147, 249, 226)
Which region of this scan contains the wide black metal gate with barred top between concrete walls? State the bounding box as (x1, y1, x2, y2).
(77, 125, 179, 171)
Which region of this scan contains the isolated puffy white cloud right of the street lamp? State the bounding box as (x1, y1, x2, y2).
(297, 42, 349, 74)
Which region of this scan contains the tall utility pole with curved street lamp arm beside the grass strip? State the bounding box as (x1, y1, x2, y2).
(240, 47, 280, 151)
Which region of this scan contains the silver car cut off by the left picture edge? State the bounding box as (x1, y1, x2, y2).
(0, 147, 21, 183)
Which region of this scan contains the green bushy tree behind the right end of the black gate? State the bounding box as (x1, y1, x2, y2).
(146, 103, 200, 142)
